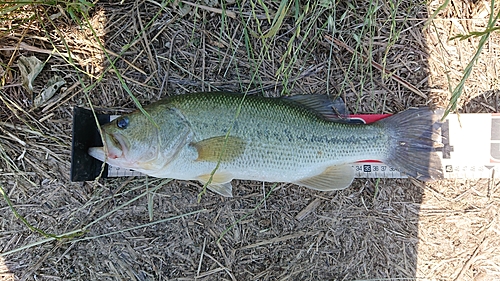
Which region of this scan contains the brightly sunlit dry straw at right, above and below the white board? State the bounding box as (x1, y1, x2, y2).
(417, 2, 500, 280)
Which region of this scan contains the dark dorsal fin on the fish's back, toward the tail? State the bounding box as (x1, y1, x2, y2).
(282, 95, 349, 122)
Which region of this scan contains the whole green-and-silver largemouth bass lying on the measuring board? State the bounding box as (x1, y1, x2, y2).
(88, 92, 443, 197)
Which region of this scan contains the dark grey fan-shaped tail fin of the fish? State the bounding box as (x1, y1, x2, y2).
(377, 108, 443, 181)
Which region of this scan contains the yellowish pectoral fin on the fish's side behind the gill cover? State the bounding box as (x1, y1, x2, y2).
(192, 136, 246, 162)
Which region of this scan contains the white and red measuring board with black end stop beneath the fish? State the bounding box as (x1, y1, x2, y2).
(71, 107, 500, 181)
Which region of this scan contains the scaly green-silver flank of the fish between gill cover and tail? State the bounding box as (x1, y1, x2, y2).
(168, 93, 388, 173)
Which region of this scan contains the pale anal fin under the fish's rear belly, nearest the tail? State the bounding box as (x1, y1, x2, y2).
(294, 164, 354, 191)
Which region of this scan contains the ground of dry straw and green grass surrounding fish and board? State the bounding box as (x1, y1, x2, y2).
(0, 0, 500, 281)
